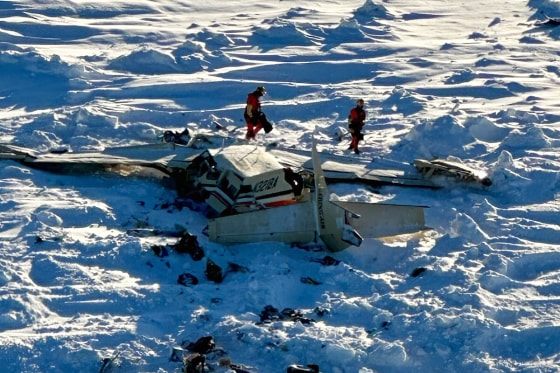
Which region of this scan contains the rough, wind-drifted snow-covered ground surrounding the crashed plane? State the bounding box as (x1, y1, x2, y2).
(0, 0, 560, 373)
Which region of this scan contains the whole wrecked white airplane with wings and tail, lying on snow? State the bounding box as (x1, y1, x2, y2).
(0, 132, 490, 251)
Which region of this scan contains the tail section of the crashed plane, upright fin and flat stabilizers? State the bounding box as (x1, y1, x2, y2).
(208, 144, 426, 251)
